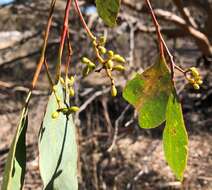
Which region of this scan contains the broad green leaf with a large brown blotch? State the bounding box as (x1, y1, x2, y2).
(123, 59, 173, 128)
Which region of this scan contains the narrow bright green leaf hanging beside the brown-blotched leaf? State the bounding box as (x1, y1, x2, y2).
(163, 93, 188, 180)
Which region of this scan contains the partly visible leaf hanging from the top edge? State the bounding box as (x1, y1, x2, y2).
(96, 0, 121, 27)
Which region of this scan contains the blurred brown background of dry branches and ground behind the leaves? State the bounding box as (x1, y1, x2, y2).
(0, 0, 212, 190)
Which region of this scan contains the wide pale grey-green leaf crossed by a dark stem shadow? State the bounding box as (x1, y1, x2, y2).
(39, 83, 78, 190)
